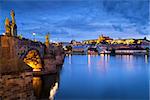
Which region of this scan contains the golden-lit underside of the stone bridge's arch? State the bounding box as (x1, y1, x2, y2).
(24, 50, 42, 71)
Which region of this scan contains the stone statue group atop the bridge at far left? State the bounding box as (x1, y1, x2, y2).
(5, 10, 17, 36)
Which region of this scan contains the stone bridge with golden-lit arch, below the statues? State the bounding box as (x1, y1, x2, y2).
(0, 35, 64, 73)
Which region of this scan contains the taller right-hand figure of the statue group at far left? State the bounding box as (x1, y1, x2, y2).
(10, 10, 17, 36)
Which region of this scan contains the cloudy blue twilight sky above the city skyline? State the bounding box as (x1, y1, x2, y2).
(0, 0, 150, 41)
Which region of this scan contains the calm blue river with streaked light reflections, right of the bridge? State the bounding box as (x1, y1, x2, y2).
(36, 55, 150, 100)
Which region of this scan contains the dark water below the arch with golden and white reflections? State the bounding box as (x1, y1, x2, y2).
(33, 73, 59, 100)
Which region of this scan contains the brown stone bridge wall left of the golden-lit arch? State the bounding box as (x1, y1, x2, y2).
(0, 36, 31, 74)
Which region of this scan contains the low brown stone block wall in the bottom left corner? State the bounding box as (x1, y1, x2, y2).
(0, 72, 35, 100)
